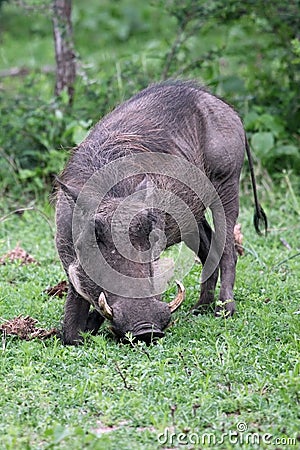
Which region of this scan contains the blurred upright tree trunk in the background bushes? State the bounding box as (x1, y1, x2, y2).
(52, 0, 76, 104)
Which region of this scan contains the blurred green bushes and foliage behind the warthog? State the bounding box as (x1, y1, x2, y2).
(0, 0, 300, 204)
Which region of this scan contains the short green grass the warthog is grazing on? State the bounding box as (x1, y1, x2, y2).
(0, 185, 300, 450)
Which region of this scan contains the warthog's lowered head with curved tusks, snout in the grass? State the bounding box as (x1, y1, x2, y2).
(60, 178, 184, 342)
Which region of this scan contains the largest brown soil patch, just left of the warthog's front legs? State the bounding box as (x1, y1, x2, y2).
(0, 315, 57, 341)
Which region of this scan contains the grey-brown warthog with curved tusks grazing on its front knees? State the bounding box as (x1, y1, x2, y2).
(56, 81, 267, 344)
